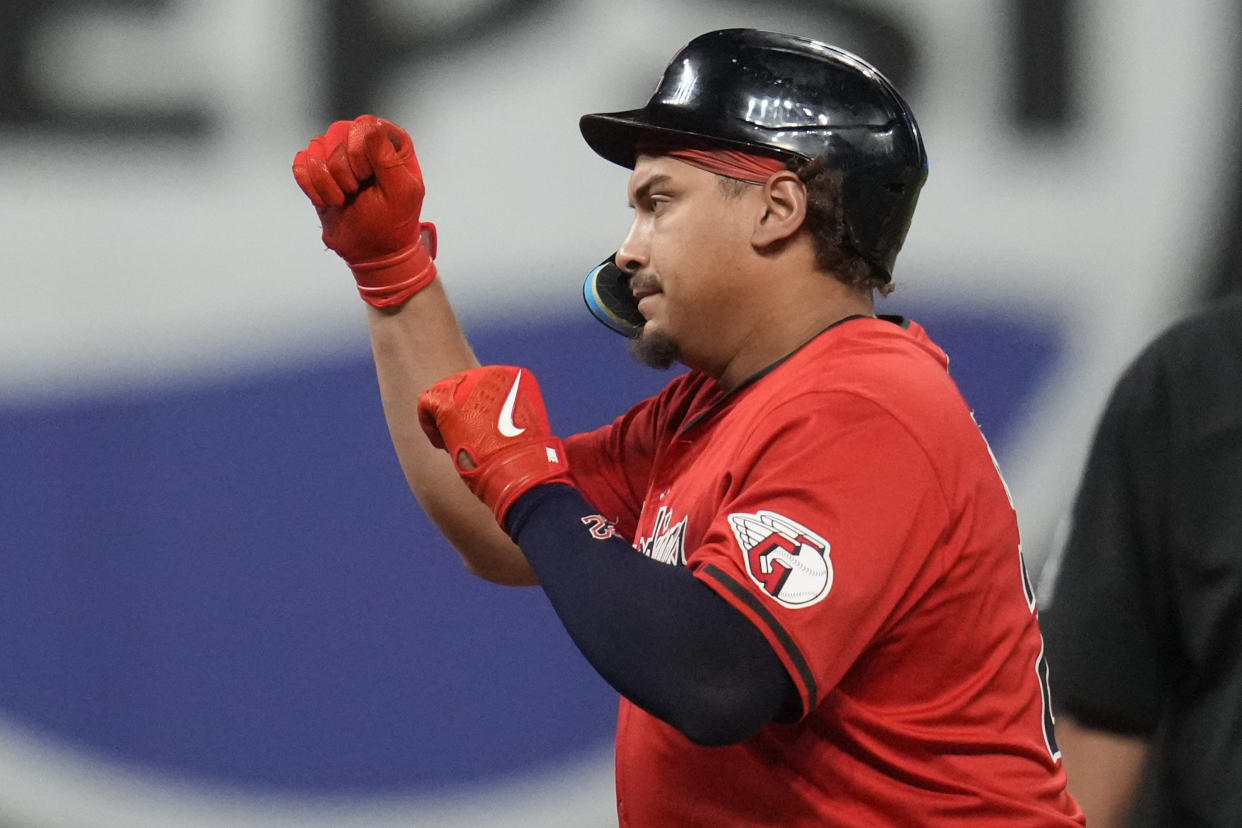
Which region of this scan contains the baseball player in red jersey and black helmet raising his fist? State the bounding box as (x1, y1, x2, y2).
(293, 30, 1083, 827)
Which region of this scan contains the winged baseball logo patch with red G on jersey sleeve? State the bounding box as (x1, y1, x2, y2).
(729, 510, 832, 610)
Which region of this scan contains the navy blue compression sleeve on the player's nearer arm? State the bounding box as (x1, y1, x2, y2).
(507, 484, 799, 745)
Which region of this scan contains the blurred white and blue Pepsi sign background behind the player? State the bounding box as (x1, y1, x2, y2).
(0, 0, 1242, 828)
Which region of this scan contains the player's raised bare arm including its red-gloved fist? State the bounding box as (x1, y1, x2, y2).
(293, 115, 537, 585)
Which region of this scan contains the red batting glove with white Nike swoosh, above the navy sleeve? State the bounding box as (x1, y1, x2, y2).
(419, 365, 573, 529)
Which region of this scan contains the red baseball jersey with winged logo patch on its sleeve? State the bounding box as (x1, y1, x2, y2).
(566, 318, 1083, 828)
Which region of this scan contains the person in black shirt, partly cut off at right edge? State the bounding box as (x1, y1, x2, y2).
(1041, 297, 1242, 828)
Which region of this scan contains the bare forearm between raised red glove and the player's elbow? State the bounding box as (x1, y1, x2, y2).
(368, 279, 537, 585)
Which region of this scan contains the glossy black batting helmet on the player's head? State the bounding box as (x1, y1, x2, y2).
(579, 29, 928, 277)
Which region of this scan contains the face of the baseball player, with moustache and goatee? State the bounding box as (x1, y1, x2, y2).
(616, 155, 761, 372)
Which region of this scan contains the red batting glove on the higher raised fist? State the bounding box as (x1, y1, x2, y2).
(293, 115, 436, 308)
